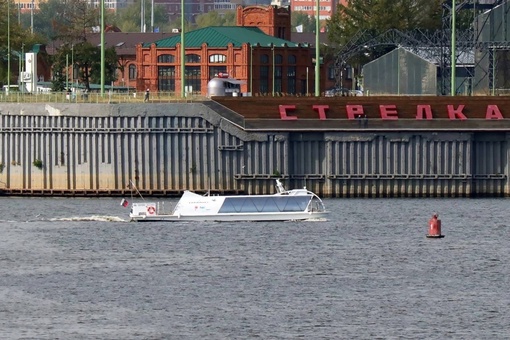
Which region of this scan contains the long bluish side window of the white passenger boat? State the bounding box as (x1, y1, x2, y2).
(219, 195, 310, 213)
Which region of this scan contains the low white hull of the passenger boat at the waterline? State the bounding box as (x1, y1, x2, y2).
(131, 211, 328, 222)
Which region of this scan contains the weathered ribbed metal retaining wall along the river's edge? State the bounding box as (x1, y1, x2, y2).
(0, 103, 509, 197)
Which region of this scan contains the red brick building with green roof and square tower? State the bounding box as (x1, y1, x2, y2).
(136, 6, 326, 95)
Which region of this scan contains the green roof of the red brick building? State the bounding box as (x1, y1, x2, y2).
(143, 26, 299, 47)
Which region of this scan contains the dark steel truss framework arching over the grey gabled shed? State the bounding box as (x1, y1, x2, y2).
(335, 0, 510, 95)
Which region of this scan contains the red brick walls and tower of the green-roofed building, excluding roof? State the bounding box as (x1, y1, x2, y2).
(136, 6, 326, 95)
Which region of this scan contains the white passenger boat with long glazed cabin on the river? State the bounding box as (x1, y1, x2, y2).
(125, 179, 327, 222)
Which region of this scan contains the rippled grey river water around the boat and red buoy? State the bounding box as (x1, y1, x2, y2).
(0, 197, 510, 339)
